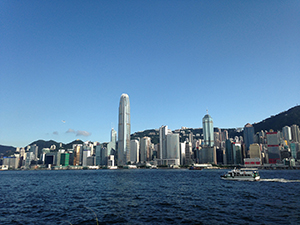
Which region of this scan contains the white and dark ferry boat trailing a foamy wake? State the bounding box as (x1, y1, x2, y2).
(221, 168, 260, 181)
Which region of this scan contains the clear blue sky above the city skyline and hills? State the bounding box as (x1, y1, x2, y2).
(0, 0, 300, 147)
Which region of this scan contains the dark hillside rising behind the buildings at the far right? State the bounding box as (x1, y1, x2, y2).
(253, 106, 300, 132)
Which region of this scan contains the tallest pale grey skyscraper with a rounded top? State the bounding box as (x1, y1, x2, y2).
(118, 94, 130, 166)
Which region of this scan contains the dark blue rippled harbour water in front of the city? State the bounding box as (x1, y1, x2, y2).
(0, 169, 300, 225)
